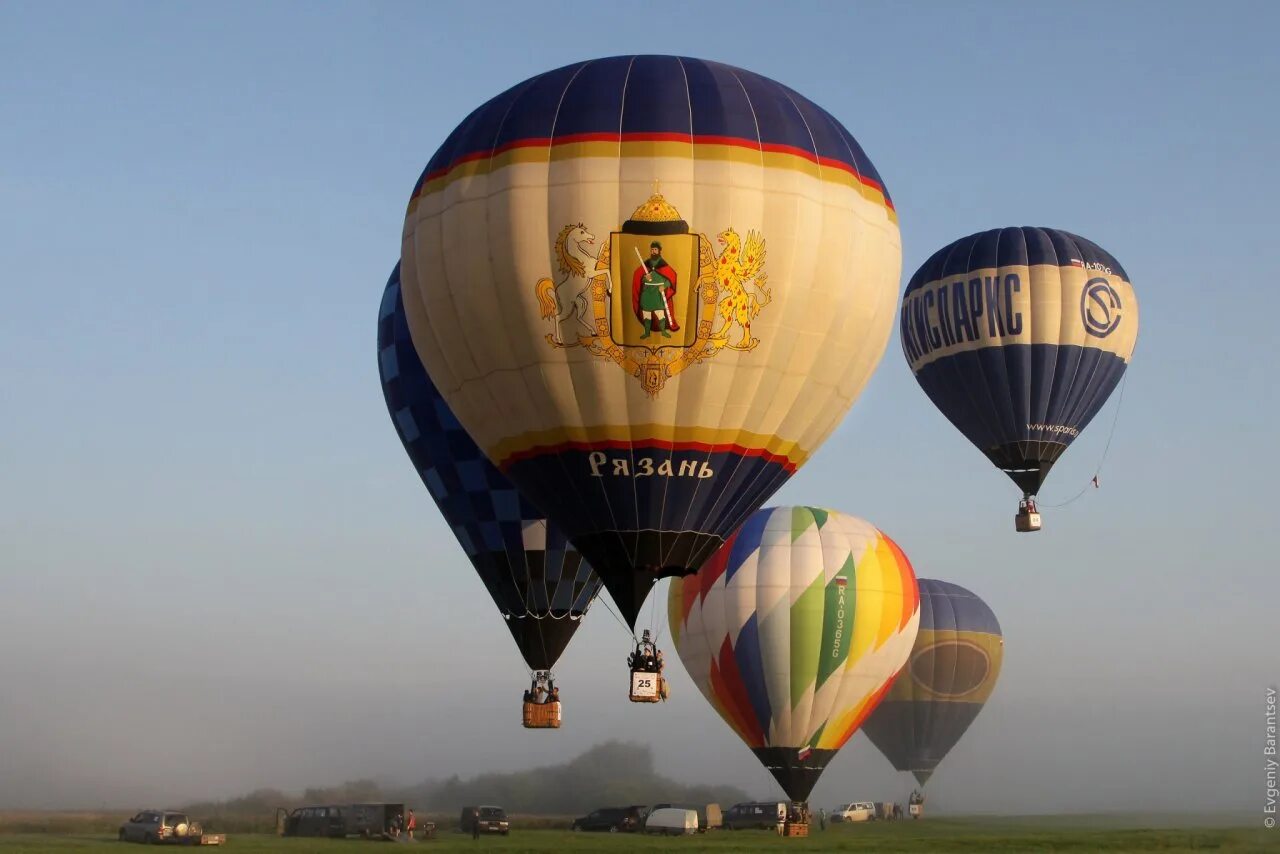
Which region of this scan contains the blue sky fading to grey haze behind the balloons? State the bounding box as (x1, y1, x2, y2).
(0, 3, 1280, 810)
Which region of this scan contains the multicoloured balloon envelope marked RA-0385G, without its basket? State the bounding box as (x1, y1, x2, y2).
(667, 507, 920, 802)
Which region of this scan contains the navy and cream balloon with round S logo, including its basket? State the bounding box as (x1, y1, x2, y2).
(900, 228, 1138, 530)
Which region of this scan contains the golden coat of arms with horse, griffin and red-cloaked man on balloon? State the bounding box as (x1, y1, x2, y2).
(534, 191, 773, 397)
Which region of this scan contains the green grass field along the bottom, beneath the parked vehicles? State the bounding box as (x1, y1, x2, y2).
(0, 817, 1280, 854)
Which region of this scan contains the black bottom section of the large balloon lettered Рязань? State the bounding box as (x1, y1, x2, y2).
(573, 531, 724, 629)
